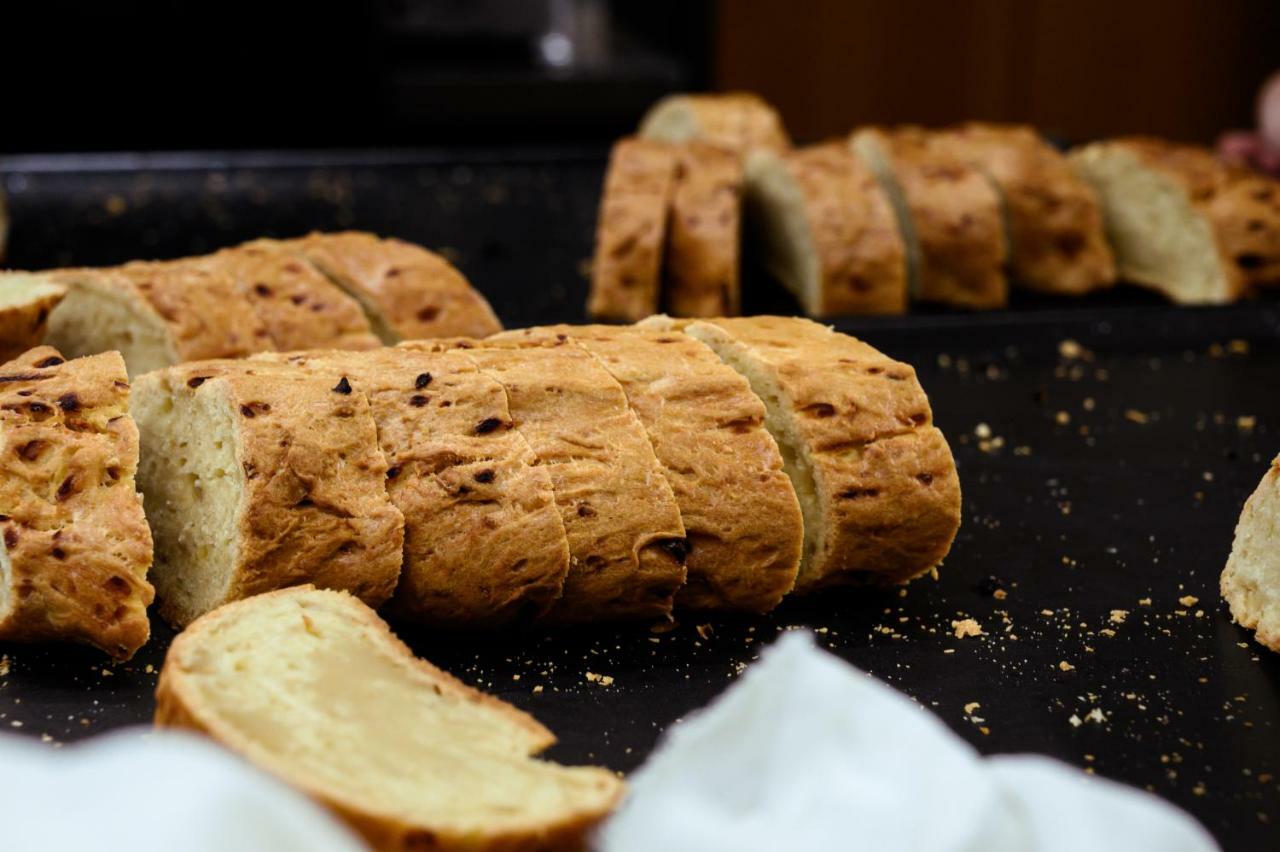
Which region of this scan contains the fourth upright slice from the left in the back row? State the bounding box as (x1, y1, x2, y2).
(850, 127, 1009, 308)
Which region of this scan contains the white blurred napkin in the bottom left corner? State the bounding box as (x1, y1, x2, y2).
(0, 730, 366, 852)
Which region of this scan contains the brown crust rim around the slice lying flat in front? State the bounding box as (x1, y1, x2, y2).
(155, 586, 625, 852)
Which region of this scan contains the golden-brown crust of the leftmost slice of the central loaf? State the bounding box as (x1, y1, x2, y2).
(138, 361, 404, 626)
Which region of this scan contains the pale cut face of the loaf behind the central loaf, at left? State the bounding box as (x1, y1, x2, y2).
(46, 274, 178, 376)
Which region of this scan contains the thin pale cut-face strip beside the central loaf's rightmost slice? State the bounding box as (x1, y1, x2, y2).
(684, 322, 826, 585)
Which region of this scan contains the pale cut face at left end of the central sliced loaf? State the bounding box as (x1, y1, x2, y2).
(132, 374, 244, 623)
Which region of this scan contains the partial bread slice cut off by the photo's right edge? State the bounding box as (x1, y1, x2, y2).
(1221, 457, 1280, 651)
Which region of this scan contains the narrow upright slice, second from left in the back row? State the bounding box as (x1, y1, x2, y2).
(664, 142, 742, 316)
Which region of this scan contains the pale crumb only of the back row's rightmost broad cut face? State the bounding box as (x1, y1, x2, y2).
(1071, 146, 1233, 304)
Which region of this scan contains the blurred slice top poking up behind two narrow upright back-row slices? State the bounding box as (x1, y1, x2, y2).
(640, 92, 791, 155)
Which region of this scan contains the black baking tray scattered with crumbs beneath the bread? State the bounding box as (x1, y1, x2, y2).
(0, 150, 1280, 849)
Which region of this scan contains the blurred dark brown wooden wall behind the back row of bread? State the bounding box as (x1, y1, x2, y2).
(714, 0, 1280, 142)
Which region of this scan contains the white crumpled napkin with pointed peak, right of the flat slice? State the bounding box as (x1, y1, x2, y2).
(596, 632, 1217, 852)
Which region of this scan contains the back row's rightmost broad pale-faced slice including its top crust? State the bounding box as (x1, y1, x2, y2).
(1071, 141, 1244, 304)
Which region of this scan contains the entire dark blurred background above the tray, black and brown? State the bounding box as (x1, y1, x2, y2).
(0, 0, 1280, 154)
